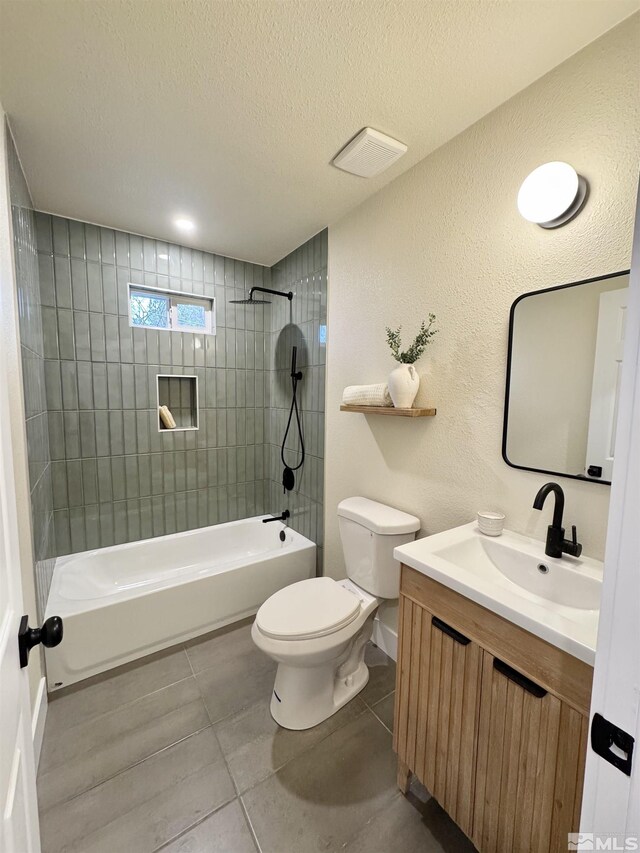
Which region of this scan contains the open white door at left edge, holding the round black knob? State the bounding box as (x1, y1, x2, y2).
(0, 130, 40, 853)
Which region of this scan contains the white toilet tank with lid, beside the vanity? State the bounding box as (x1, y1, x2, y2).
(338, 497, 420, 598)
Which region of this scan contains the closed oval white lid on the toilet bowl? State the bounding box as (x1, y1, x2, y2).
(256, 577, 360, 640)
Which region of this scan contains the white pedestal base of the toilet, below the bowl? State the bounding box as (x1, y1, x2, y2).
(271, 661, 369, 731)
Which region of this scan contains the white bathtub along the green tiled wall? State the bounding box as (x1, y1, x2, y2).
(45, 516, 316, 691)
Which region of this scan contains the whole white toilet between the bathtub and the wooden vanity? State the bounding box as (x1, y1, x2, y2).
(251, 497, 420, 729)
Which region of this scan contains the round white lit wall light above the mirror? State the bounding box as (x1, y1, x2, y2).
(518, 161, 589, 228)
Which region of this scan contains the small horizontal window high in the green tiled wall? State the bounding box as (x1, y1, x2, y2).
(129, 284, 216, 335)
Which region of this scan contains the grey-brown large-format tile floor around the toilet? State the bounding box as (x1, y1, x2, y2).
(38, 622, 474, 853)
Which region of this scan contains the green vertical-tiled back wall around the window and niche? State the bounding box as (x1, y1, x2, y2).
(36, 213, 271, 555)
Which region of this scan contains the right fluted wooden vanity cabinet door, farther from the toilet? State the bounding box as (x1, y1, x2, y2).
(472, 652, 566, 853)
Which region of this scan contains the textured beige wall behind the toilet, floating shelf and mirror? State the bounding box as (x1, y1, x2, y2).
(325, 15, 640, 588)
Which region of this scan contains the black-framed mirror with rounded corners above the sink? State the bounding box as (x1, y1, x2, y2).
(502, 270, 629, 483)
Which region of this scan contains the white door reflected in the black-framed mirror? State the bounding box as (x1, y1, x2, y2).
(586, 287, 629, 482)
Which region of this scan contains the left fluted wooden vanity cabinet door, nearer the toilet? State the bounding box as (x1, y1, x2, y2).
(394, 596, 482, 835)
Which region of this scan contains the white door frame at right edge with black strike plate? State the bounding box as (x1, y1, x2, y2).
(579, 191, 640, 832)
